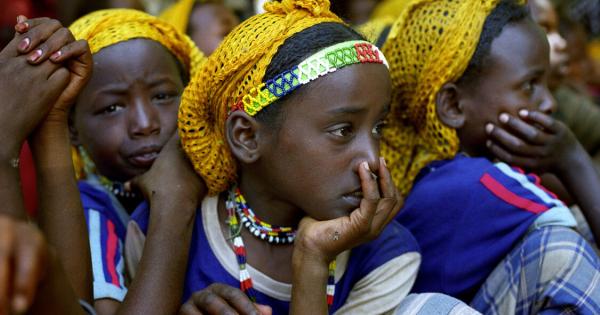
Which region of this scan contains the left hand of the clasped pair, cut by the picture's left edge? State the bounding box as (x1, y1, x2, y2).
(0, 17, 69, 159)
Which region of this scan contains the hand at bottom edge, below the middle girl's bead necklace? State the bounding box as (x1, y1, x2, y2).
(179, 283, 272, 315)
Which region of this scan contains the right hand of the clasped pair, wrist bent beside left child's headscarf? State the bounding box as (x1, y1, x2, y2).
(15, 16, 93, 123)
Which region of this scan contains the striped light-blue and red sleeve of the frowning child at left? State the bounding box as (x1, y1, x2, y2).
(86, 209, 127, 302)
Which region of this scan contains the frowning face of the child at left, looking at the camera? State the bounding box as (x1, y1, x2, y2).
(71, 39, 184, 181)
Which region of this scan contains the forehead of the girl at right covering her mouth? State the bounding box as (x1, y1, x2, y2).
(484, 19, 549, 74)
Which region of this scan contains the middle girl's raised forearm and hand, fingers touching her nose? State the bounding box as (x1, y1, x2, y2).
(290, 158, 402, 314)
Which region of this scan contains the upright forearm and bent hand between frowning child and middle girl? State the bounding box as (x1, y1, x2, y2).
(96, 136, 206, 314)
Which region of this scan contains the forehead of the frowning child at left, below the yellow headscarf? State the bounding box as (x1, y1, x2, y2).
(89, 39, 180, 86)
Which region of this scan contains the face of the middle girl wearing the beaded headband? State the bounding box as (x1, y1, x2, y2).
(242, 64, 391, 220)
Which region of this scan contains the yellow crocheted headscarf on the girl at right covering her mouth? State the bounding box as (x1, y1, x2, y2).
(381, 0, 524, 195)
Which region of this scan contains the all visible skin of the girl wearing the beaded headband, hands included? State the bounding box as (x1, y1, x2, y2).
(184, 64, 402, 314)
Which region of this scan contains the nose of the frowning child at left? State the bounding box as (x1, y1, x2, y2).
(129, 97, 160, 138)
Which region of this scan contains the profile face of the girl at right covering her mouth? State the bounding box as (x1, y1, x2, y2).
(457, 19, 555, 156)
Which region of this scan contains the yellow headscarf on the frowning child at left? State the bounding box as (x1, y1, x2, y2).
(69, 9, 205, 179)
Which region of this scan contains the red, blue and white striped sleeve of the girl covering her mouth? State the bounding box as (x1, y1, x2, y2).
(480, 163, 576, 227)
